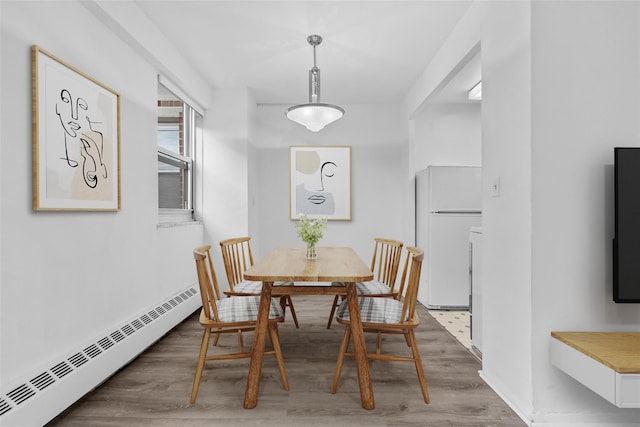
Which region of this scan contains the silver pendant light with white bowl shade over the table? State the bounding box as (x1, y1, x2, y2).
(286, 35, 344, 132)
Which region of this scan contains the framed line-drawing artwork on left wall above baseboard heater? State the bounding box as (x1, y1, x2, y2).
(31, 46, 120, 211)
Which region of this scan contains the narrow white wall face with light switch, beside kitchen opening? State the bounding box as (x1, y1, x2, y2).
(481, 2, 534, 418)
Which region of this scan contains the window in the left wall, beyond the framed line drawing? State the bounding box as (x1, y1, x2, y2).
(158, 83, 202, 222)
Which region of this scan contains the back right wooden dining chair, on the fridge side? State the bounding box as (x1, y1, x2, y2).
(327, 237, 402, 329)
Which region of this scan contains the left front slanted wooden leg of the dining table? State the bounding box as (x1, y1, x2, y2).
(244, 282, 273, 409)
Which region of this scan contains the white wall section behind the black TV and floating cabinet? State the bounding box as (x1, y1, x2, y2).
(531, 1, 640, 425)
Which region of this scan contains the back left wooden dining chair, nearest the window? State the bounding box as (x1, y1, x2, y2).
(220, 237, 300, 328)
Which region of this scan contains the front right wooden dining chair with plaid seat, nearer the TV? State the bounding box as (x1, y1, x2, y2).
(331, 247, 429, 403)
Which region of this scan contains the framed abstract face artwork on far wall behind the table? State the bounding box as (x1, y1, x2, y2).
(289, 146, 351, 220)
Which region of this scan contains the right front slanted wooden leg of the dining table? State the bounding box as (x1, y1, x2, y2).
(346, 282, 375, 409)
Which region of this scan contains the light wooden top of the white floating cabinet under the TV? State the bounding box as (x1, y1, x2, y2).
(551, 332, 640, 374)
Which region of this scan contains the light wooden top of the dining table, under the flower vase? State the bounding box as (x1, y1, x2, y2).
(244, 246, 373, 282)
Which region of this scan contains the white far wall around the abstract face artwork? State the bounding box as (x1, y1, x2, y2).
(250, 105, 413, 262)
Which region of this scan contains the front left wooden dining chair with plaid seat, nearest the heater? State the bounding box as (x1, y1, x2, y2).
(191, 246, 289, 403)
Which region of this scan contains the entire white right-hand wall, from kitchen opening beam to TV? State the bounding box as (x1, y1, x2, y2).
(405, 1, 640, 426)
